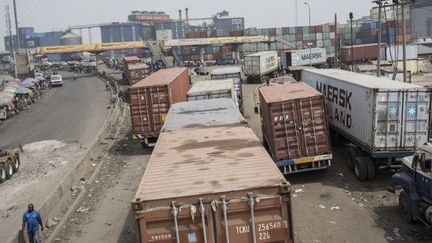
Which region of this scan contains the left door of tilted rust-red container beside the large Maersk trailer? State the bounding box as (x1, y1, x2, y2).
(270, 101, 303, 160)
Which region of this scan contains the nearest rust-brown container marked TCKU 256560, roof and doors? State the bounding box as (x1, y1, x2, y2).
(132, 124, 294, 243)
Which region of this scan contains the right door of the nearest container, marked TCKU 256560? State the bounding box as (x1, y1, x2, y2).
(214, 197, 293, 243)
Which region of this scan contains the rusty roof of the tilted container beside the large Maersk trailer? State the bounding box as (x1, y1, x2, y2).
(259, 83, 321, 103)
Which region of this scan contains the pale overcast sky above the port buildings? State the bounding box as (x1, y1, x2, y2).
(0, 0, 373, 50)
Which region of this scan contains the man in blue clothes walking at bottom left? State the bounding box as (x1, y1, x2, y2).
(22, 203, 44, 243)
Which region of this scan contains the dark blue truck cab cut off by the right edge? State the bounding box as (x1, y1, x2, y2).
(391, 144, 432, 226)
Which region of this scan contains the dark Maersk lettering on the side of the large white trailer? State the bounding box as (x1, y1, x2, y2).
(316, 81, 352, 128)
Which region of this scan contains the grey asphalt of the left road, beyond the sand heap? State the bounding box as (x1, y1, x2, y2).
(0, 74, 109, 147)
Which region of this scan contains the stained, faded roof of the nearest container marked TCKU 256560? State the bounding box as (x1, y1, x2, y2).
(134, 125, 286, 202)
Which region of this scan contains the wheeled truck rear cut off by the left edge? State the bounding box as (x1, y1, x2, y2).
(0, 148, 20, 183)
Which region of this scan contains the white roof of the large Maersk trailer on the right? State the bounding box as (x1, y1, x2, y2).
(302, 69, 427, 90)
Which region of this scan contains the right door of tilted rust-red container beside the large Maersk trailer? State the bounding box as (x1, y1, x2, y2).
(296, 96, 331, 157)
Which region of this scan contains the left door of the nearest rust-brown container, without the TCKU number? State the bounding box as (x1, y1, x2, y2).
(137, 205, 215, 243)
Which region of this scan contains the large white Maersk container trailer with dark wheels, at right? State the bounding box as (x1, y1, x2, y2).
(301, 69, 431, 181)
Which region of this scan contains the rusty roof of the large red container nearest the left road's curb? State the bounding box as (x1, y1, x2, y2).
(131, 68, 187, 88)
